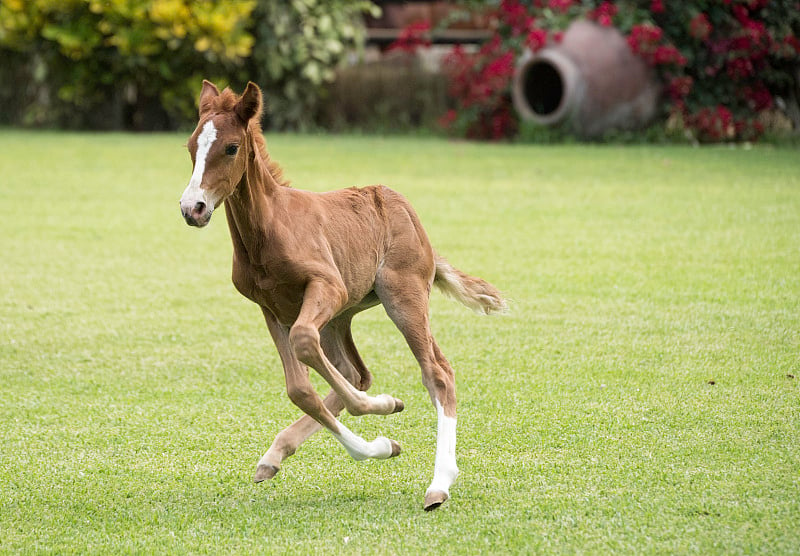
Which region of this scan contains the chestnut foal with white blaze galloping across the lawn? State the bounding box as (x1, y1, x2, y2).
(180, 81, 505, 510)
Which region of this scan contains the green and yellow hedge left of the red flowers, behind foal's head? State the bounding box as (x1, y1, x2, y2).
(0, 0, 375, 129)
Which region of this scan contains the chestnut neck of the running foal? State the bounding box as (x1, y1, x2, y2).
(225, 127, 282, 263)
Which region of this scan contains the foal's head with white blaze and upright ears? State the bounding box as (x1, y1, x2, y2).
(180, 80, 261, 227)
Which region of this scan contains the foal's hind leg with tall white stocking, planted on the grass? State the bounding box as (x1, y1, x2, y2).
(376, 272, 458, 511)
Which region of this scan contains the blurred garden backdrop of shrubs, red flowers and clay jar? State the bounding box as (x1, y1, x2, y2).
(0, 0, 800, 142)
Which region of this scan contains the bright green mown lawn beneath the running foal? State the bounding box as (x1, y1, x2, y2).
(0, 130, 800, 554)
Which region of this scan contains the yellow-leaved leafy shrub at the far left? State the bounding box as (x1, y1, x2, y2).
(0, 0, 255, 128)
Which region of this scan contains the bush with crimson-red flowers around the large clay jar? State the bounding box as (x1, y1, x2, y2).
(441, 0, 800, 141)
